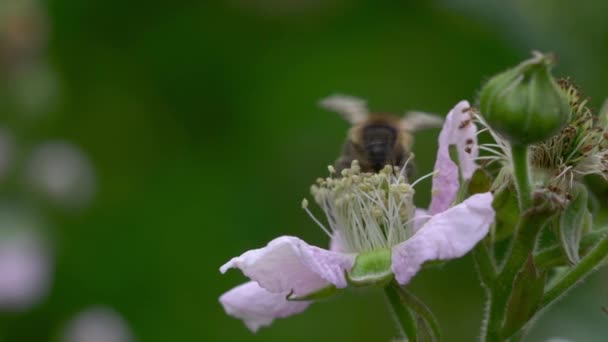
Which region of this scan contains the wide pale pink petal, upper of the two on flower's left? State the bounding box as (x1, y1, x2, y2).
(220, 236, 355, 296)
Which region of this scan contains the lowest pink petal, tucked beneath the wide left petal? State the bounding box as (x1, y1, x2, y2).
(220, 281, 310, 332)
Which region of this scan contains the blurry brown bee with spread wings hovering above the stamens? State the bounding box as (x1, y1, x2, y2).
(319, 95, 443, 179)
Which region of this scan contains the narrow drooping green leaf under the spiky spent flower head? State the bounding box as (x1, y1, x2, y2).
(559, 185, 589, 264)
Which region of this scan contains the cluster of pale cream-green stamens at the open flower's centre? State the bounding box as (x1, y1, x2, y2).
(303, 161, 415, 253)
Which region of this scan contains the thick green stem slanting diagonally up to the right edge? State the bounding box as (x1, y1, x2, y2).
(541, 237, 608, 308)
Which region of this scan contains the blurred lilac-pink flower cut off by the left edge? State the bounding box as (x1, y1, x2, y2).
(0, 205, 52, 311)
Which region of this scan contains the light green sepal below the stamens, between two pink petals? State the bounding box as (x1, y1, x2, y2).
(346, 249, 394, 287)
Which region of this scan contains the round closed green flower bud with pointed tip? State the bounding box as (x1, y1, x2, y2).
(479, 53, 570, 145)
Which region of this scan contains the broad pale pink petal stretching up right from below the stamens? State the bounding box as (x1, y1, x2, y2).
(392, 192, 494, 285)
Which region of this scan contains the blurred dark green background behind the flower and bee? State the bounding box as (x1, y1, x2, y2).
(0, 0, 608, 342)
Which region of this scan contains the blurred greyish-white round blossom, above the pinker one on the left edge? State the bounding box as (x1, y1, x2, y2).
(27, 141, 96, 208)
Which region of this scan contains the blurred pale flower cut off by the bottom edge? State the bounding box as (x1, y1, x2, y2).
(62, 307, 134, 342)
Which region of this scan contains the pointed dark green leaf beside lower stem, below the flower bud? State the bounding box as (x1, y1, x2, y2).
(502, 254, 546, 338)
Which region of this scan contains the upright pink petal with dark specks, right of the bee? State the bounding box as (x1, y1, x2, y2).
(429, 101, 479, 215)
